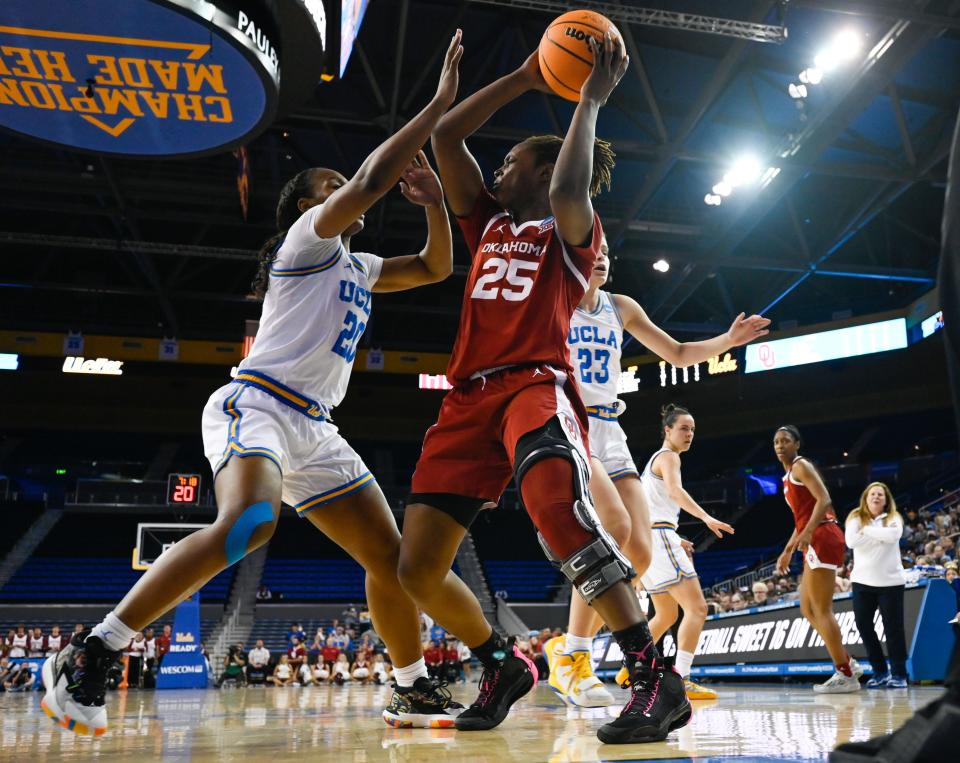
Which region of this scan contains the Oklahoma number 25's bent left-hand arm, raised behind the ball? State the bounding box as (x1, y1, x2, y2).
(430, 52, 550, 217)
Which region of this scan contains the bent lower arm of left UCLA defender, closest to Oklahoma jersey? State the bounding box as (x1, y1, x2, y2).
(373, 151, 453, 292)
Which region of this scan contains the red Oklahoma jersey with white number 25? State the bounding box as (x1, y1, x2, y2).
(447, 189, 603, 384)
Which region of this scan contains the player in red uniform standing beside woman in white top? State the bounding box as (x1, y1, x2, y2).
(773, 424, 863, 694)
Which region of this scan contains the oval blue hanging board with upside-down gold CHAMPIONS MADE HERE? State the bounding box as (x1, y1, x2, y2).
(0, 0, 280, 156)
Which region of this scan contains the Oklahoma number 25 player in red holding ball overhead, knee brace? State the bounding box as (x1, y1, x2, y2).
(399, 36, 690, 742)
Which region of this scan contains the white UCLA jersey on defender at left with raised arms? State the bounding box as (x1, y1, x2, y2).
(239, 200, 383, 408)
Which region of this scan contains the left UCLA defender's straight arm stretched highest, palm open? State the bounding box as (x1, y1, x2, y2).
(314, 29, 463, 238)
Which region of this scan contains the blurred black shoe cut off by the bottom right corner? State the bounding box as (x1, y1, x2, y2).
(829, 695, 960, 763)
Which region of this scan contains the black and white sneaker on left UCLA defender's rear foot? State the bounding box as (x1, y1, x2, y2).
(40, 630, 120, 736)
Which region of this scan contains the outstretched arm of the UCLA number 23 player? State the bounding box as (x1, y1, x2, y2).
(613, 294, 770, 368)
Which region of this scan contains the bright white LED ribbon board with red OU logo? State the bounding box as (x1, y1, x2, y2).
(745, 318, 907, 374)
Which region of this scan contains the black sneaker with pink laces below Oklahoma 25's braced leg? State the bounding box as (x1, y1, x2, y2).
(597, 658, 693, 744)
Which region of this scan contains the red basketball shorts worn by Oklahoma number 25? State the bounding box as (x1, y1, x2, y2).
(410, 365, 590, 502)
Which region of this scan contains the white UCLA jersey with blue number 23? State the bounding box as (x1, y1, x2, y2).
(567, 291, 623, 405)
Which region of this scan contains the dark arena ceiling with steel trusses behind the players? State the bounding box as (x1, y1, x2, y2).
(0, 0, 960, 351)
